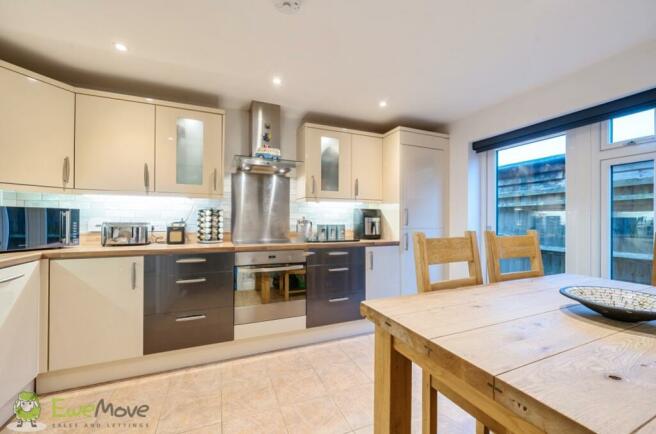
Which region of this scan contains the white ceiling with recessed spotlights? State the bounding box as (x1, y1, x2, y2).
(0, 0, 656, 128)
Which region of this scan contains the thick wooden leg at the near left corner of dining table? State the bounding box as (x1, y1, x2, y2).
(374, 327, 412, 434)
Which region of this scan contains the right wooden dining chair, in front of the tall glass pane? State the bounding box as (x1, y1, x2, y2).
(485, 230, 544, 283)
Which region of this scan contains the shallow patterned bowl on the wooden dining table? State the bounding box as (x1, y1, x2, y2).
(560, 286, 656, 322)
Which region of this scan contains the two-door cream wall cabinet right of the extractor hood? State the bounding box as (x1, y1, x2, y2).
(297, 124, 382, 200)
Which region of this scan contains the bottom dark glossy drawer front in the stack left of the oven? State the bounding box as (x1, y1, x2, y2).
(144, 307, 234, 354)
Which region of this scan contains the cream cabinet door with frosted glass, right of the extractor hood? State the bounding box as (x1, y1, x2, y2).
(305, 127, 352, 199)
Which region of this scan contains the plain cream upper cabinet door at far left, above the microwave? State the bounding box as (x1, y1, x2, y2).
(0, 67, 75, 188)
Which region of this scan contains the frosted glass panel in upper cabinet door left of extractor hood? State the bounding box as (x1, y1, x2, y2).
(175, 118, 203, 185)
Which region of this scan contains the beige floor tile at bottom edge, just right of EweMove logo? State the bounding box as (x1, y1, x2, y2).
(157, 393, 221, 434)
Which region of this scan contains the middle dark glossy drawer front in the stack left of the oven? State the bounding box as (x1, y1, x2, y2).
(144, 271, 234, 315)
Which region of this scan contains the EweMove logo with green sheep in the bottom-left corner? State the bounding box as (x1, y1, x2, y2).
(7, 392, 150, 432)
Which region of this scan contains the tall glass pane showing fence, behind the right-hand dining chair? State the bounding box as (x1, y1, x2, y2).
(496, 135, 566, 274)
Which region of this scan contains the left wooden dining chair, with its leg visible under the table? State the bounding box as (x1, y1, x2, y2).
(413, 231, 489, 434)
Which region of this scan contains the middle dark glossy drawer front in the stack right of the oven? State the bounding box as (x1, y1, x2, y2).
(307, 264, 365, 300)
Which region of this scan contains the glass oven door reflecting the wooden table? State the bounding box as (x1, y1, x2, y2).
(234, 264, 306, 325)
